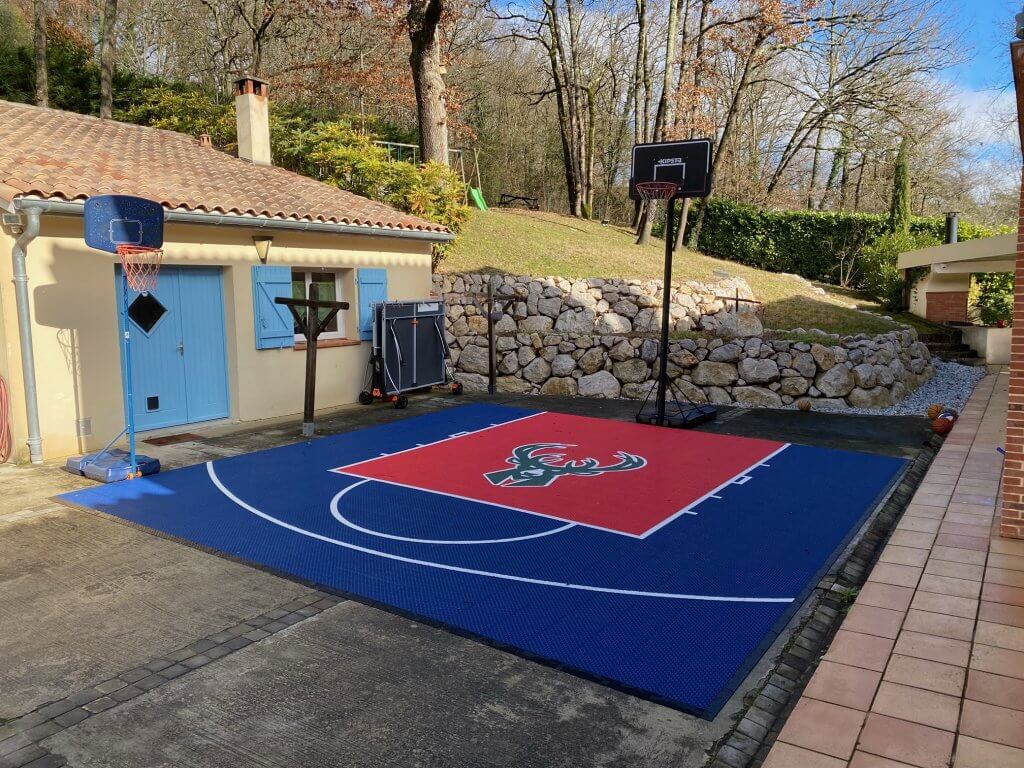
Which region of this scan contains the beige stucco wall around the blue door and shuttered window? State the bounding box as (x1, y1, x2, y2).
(0, 216, 431, 460)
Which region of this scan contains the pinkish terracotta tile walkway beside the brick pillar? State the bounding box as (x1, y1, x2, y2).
(764, 374, 1024, 768)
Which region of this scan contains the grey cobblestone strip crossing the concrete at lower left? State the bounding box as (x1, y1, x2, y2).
(0, 592, 343, 768)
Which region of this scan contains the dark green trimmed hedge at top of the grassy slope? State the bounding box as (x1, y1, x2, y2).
(687, 199, 997, 285)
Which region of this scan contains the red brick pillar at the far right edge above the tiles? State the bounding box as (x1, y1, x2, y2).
(999, 167, 1024, 539)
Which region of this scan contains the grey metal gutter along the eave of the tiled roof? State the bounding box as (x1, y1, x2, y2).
(12, 198, 456, 243)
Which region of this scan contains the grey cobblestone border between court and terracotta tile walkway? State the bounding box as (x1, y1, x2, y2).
(706, 437, 942, 768)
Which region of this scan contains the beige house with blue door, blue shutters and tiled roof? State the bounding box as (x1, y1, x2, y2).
(0, 78, 453, 462)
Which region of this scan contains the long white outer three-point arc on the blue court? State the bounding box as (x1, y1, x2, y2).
(206, 462, 794, 603)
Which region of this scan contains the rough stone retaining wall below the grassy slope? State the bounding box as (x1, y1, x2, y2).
(434, 274, 934, 408)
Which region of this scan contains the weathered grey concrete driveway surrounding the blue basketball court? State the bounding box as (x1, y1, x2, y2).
(0, 396, 927, 768)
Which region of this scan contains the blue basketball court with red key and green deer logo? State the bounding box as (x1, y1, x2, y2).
(61, 404, 905, 718)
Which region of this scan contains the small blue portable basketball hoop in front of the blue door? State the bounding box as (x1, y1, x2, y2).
(67, 195, 164, 482)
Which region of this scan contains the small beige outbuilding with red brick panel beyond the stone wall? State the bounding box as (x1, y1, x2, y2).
(896, 234, 1017, 366)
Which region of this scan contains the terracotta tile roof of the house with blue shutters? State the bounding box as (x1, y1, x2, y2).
(0, 100, 447, 232)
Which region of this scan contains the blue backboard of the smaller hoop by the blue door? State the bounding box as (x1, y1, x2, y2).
(85, 195, 164, 253)
